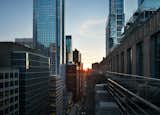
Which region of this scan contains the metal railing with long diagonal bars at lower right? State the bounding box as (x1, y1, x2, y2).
(105, 72, 160, 115)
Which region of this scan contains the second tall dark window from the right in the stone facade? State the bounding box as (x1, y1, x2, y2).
(136, 42, 144, 75)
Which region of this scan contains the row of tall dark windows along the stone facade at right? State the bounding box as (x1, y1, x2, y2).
(108, 34, 160, 78)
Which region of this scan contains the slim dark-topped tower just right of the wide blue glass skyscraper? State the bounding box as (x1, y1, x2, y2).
(66, 36, 73, 63)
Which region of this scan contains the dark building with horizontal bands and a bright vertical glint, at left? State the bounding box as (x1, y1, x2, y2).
(0, 42, 50, 115)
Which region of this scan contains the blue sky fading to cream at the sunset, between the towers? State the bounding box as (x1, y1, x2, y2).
(0, 0, 137, 69)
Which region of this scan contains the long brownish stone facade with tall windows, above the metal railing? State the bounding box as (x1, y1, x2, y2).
(100, 10, 160, 78)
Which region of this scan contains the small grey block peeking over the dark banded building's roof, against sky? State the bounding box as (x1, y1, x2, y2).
(15, 38, 33, 48)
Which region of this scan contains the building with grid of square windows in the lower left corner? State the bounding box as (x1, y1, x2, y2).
(0, 68, 20, 115)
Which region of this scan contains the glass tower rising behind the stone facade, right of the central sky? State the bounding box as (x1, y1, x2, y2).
(106, 0, 125, 56)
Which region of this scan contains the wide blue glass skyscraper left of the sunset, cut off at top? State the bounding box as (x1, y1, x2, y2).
(33, 0, 65, 75)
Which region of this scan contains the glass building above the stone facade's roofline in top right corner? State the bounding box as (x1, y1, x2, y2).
(121, 0, 160, 42)
